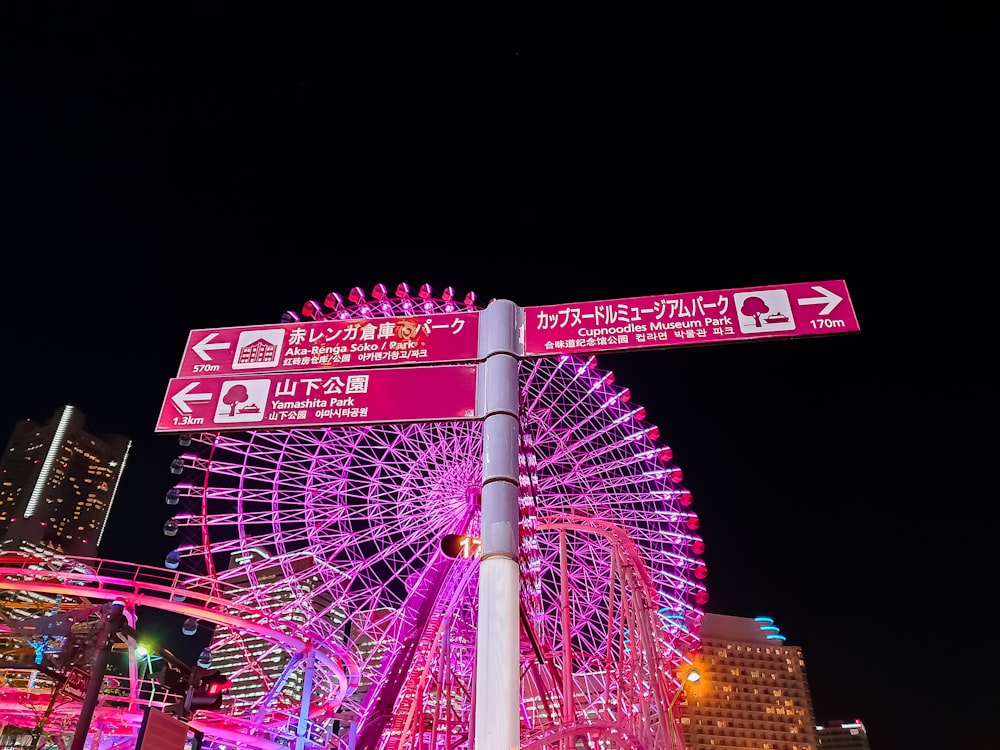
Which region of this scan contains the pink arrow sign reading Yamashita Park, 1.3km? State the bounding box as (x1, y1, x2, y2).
(156, 365, 477, 432)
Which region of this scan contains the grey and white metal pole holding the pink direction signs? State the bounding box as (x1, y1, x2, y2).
(474, 300, 521, 750)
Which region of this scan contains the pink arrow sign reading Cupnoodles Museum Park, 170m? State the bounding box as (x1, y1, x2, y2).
(524, 281, 860, 357)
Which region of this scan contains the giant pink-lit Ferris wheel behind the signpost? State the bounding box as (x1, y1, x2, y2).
(168, 284, 708, 750)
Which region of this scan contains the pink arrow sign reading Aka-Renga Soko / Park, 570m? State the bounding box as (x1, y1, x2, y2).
(177, 312, 479, 378)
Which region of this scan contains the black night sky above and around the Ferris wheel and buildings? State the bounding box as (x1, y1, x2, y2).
(0, 2, 1000, 750)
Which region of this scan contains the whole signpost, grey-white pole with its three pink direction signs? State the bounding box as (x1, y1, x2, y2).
(156, 281, 860, 750)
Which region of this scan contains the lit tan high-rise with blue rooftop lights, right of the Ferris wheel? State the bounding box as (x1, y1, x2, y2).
(680, 613, 818, 750)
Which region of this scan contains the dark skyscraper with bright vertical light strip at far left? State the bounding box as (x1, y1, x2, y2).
(0, 406, 132, 557)
